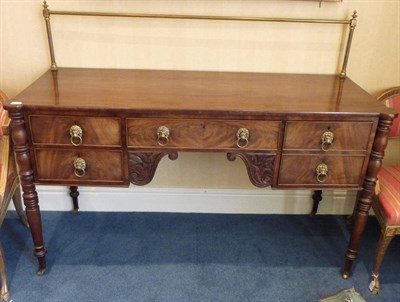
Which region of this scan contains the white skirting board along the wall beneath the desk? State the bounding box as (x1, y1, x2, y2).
(10, 186, 356, 215)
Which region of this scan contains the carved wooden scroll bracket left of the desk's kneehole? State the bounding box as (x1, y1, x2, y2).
(128, 151, 178, 186)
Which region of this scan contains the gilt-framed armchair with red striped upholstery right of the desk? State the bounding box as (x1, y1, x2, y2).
(369, 87, 400, 294)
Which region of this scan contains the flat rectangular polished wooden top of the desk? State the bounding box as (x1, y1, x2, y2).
(12, 68, 393, 115)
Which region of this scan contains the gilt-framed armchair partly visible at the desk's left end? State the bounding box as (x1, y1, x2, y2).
(0, 90, 28, 301)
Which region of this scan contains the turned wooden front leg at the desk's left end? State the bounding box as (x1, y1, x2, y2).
(5, 102, 46, 275)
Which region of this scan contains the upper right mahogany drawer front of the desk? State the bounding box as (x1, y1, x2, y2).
(283, 122, 373, 151)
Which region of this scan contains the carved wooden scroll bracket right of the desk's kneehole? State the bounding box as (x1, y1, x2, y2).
(227, 153, 275, 188)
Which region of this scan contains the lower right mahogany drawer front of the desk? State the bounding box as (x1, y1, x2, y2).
(278, 155, 366, 187)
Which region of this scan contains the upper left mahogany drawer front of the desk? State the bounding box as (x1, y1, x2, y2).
(29, 115, 121, 146)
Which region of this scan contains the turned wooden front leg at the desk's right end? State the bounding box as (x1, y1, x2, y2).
(342, 114, 393, 279)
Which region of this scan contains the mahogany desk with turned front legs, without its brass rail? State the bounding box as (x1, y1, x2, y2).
(6, 68, 395, 277)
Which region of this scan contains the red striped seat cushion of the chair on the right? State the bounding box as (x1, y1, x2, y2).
(378, 165, 400, 225)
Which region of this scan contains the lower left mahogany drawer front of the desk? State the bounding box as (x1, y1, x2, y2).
(35, 149, 123, 183)
